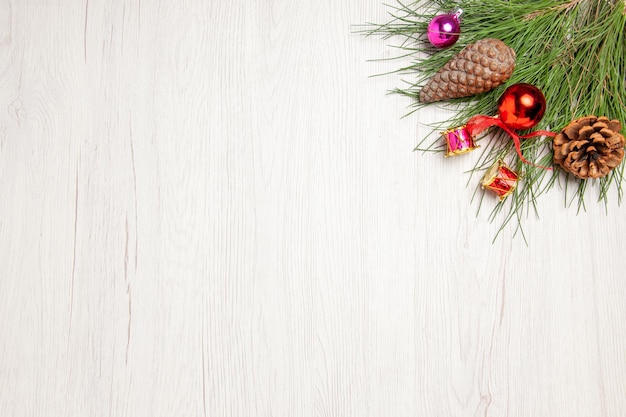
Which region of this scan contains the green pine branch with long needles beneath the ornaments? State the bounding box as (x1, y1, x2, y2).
(362, 0, 626, 235)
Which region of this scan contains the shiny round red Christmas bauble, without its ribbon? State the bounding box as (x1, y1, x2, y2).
(498, 83, 546, 130)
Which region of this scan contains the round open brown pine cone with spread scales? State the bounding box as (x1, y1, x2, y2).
(553, 116, 624, 179)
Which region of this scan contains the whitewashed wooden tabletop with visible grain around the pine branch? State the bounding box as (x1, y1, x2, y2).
(0, 0, 626, 417)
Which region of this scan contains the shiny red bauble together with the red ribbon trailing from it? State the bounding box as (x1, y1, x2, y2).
(465, 83, 556, 169)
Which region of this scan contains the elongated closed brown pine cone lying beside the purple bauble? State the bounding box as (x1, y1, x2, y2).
(420, 38, 515, 103)
